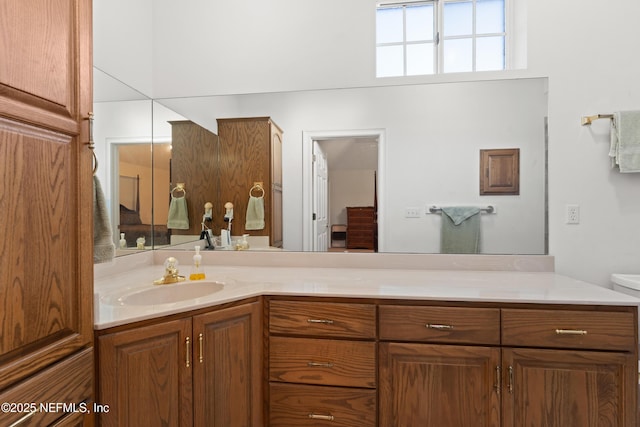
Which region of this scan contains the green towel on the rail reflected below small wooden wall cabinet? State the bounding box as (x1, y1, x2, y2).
(440, 206, 480, 254)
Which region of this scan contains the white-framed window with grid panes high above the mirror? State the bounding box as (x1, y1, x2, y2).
(376, 0, 507, 77)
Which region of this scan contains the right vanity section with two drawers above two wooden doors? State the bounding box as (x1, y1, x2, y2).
(379, 305, 638, 427)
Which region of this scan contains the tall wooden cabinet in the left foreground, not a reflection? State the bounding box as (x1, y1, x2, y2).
(0, 0, 93, 425)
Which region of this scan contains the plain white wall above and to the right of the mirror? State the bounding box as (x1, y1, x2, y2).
(94, 0, 640, 285)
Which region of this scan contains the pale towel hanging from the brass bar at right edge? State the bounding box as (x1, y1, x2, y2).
(609, 111, 640, 173)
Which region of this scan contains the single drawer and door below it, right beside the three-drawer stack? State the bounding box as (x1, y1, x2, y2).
(379, 305, 501, 427)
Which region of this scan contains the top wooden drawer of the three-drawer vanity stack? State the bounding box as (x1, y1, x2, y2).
(269, 301, 376, 339)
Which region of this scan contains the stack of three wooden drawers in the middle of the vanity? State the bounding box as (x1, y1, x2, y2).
(268, 299, 377, 427)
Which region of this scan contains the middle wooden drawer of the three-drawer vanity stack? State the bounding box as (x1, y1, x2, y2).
(269, 337, 376, 387)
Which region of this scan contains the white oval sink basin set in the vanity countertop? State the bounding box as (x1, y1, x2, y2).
(100, 281, 224, 305)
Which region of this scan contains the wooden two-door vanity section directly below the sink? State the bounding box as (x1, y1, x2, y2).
(97, 301, 262, 427)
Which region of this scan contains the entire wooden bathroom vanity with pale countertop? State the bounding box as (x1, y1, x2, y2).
(95, 251, 640, 427)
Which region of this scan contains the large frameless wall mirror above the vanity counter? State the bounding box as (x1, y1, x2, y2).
(94, 70, 547, 260)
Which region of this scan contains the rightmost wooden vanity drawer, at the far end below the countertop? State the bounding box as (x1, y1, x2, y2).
(502, 309, 636, 351)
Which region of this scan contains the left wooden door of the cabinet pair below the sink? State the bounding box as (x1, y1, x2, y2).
(97, 319, 193, 426)
